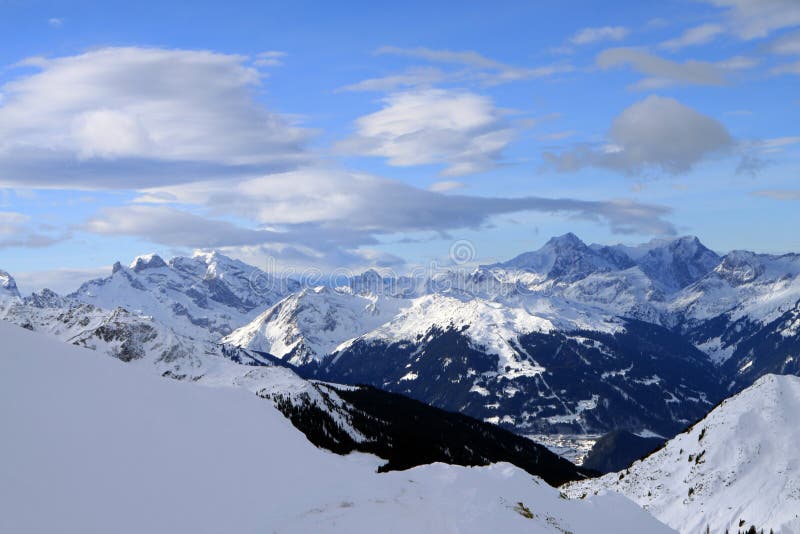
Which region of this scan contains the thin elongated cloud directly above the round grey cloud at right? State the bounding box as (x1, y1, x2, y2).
(596, 48, 725, 89)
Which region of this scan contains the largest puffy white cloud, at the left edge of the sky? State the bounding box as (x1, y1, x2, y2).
(0, 48, 311, 188)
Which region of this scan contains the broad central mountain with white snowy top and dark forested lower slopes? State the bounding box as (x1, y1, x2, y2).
(224, 288, 719, 440)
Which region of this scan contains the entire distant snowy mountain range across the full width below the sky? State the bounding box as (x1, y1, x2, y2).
(0, 234, 800, 448)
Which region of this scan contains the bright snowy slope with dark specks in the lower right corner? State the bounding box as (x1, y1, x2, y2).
(567, 375, 800, 534)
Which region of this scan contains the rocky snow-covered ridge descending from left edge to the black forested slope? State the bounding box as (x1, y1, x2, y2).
(0, 292, 366, 444)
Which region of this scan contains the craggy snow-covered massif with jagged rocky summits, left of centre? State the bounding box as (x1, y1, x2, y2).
(69, 252, 298, 340)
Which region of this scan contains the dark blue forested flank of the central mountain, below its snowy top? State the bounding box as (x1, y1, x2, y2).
(301, 320, 723, 442)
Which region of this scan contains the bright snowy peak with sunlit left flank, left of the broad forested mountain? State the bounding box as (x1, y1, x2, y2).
(222, 286, 408, 365)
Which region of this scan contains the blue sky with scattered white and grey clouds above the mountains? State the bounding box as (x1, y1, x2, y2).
(0, 0, 800, 289)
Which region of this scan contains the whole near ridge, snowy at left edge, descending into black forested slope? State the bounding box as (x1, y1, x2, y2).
(0, 276, 600, 484)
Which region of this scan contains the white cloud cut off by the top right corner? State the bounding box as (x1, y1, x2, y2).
(705, 0, 800, 40)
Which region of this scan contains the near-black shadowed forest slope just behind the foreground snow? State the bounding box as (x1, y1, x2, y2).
(273, 384, 598, 486)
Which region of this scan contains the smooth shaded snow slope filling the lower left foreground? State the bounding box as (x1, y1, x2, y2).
(0, 322, 670, 534)
